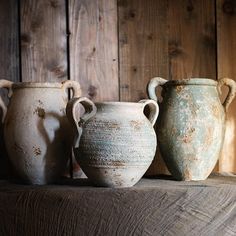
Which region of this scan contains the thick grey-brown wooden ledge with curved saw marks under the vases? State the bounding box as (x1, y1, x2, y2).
(0, 174, 236, 236)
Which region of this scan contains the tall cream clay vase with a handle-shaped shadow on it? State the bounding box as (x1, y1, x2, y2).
(0, 80, 81, 184)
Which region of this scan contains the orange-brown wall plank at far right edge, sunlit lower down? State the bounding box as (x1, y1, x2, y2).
(216, 0, 236, 172)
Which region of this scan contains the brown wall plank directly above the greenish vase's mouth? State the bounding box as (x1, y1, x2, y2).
(168, 0, 216, 79)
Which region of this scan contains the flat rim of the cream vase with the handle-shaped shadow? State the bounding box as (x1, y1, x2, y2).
(12, 82, 63, 88)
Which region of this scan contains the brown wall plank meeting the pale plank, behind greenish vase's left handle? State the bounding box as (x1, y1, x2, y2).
(118, 0, 168, 102)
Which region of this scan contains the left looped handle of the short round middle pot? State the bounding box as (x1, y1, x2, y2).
(66, 97, 97, 148)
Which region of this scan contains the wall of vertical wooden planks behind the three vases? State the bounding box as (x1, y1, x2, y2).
(0, 0, 236, 177)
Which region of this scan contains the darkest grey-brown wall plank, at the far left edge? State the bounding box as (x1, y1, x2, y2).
(0, 0, 20, 177)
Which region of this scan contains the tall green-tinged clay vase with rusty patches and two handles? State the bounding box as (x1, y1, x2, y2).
(148, 77, 236, 181)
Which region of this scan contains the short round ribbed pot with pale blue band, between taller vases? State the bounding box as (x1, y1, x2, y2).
(67, 99, 159, 188)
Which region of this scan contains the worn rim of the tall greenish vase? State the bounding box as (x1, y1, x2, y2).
(164, 78, 218, 86)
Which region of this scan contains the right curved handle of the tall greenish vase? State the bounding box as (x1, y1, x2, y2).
(218, 78, 236, 111)
